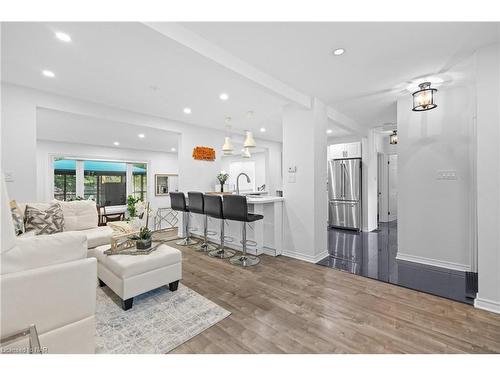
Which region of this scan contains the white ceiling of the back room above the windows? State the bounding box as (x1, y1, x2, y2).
(37, 108, 179, 152)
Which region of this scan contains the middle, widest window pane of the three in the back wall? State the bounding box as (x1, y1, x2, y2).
(83, 160, 127, 206)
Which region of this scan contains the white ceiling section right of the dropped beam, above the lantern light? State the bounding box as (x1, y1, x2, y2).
(182, 22, 499, 127)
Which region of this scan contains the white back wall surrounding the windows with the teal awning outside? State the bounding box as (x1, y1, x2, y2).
(35, 140, 178, 212)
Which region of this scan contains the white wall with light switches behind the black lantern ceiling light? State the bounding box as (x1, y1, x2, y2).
(397, 86, 474, 270)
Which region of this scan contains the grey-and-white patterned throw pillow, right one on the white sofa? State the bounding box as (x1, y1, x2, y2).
(25, 203, 64, 235)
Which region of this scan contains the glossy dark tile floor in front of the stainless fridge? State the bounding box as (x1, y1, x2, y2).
(317, 221, 474, 304)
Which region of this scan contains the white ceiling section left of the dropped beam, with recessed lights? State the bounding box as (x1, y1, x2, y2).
(2, 22, 286, 140)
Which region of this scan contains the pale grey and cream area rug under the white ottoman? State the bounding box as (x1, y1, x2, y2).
(96, 284, 231, 354)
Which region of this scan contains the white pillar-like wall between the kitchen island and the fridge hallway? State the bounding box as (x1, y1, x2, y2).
(283, 100, 328, 262)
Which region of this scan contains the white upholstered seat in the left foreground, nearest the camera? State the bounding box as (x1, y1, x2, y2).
(0, 176, 97, 353)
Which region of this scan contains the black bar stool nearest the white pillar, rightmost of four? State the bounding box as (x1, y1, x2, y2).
(223, 195, 264, 267)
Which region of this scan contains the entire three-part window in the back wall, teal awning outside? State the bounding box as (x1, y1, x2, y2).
(53, 158, 148, 206)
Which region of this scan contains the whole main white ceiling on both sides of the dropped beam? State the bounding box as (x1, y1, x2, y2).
(2, 22, 498, 140)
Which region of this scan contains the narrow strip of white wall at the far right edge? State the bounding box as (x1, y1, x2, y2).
(475, 45, 500, 313)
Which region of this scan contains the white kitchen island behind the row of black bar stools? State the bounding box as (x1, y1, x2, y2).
(179, 195, 284, 256)
